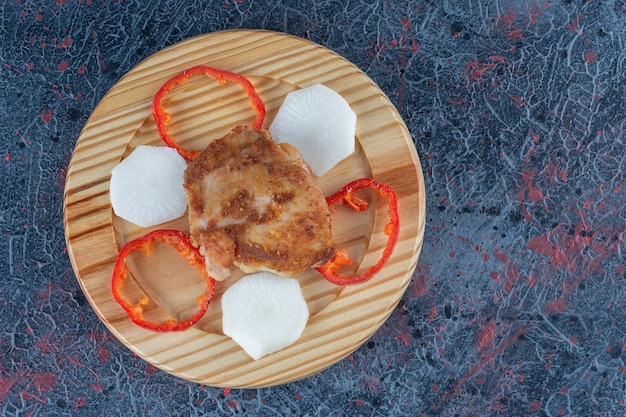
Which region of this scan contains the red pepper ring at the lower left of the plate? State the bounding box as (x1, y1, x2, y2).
(111, 230, 215, 332)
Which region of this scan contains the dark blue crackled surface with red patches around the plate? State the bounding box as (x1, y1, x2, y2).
(0, 0, 626, 417)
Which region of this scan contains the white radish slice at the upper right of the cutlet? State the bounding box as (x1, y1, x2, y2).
(268, 84, 356, 176)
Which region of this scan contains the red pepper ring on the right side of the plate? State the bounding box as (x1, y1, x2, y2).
(315, 178, 400, 285)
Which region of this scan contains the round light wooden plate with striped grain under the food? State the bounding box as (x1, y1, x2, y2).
(64, 30, 426, 388)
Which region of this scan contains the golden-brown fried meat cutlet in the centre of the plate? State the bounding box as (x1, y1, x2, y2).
(184, 127, 334, 280)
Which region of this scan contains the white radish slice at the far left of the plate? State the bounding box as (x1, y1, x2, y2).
(109, 145, 187, 227)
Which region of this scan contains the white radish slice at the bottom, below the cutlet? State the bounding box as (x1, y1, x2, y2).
(222, 272, 309, 360)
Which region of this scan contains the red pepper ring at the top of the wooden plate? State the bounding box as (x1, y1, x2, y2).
(152, 65, 265, 161)
